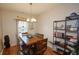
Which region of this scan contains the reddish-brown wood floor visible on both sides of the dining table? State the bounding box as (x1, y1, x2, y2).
(3, 46, 58, 55)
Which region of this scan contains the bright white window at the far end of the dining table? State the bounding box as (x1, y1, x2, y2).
(18, 21, 28, 34)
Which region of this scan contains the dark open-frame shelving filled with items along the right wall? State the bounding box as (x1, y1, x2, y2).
(53, 13, 79, 55)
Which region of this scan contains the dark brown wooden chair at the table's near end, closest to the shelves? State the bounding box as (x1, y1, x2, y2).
(35, 38, 48, 55)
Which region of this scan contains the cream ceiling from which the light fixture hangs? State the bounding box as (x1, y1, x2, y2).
(0, 3, 58, 15)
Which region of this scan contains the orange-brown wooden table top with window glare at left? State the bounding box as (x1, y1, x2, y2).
(20, 35, 42, 45)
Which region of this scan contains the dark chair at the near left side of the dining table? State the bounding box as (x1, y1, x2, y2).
(17, 38, 33, 55)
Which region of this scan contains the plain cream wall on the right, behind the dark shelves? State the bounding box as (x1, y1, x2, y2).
(37, 4, 79, 41)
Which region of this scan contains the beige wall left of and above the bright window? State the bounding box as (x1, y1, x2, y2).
(1, 10, 37, 46)
